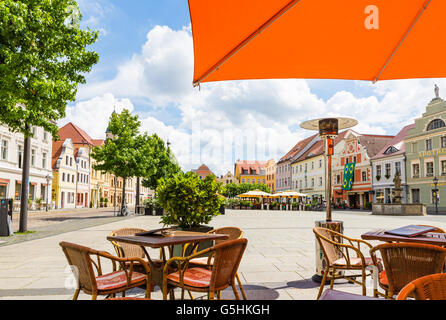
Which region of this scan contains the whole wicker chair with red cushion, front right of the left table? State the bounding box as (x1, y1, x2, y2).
(163, 238, 248, 300)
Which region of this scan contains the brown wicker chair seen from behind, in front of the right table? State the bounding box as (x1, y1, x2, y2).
(370, 242, 446, 299)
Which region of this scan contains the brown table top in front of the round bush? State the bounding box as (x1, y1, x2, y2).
(107, 230, 229, 248)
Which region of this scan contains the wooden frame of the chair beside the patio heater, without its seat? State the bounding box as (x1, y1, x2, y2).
(313, 228, 381, 300)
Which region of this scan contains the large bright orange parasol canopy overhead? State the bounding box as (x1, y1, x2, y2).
(189, 0, 446, 85)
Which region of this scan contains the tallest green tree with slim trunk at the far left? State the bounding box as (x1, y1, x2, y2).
(0, 0, 99, 232)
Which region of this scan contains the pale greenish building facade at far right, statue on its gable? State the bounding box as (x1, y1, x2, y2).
(405, 95, 446, 213)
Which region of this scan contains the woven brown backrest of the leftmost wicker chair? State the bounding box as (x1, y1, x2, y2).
(59, 241, 97, 292)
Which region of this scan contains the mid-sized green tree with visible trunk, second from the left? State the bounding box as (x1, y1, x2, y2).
(91, 109, 153, 215)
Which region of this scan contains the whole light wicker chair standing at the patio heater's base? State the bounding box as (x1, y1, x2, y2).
(313, 228, 382, 300)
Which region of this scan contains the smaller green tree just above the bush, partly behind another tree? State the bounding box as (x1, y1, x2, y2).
(142, 134, 182, 190)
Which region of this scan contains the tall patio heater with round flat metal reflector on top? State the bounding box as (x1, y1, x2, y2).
(300, 118, 358, 283)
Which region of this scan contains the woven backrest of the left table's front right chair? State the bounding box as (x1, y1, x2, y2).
(210, 238, 248, 289)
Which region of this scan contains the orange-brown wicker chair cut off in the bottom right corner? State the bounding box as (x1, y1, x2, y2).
(396, 273, 446, 300)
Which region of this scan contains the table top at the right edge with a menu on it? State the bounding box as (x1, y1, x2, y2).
(361, 229, 446, 246)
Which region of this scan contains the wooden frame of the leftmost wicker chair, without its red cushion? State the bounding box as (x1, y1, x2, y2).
(60, 242, 151, 300)
